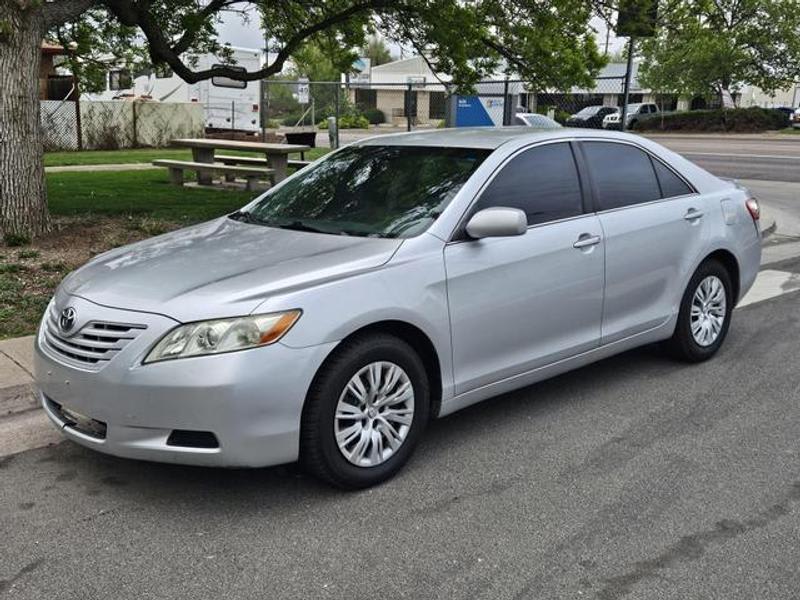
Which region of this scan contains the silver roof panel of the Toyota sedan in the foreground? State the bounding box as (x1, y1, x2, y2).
(357, 125, 641, 150)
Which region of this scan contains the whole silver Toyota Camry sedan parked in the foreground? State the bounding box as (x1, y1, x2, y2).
(34, 127, 761, 488)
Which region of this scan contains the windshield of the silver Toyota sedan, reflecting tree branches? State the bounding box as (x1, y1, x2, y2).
(238, 145, 490, 238)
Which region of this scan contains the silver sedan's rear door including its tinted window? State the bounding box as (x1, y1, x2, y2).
(581, 140, 708, 344)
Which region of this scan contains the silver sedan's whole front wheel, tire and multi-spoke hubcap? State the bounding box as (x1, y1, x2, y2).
(300, 333, 430, 488)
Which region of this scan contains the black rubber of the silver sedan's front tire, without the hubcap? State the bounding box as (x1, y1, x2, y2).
(300, 333, 430, 489)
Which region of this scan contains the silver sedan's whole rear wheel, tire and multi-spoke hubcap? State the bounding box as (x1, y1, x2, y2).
(668, 260, 734, 362)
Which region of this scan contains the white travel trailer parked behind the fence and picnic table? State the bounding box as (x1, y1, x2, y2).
(86, 46, 264, 132)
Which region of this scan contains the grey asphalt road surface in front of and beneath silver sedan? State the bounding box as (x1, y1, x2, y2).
(0, 132, 800, 600)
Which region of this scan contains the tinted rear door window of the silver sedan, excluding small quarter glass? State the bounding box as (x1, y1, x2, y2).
(583, 142, 661, 210)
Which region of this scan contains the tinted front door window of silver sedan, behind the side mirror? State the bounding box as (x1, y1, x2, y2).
(476, 143, 583, 225)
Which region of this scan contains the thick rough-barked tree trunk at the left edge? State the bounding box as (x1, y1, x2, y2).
(0, 0, 50, 239)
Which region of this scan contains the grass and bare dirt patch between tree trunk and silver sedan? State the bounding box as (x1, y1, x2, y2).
(0, 164, 312, 339)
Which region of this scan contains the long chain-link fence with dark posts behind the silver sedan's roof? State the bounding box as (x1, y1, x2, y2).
(262, 76, 636, 145)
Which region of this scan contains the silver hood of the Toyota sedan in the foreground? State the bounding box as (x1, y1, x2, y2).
(61, 217, 402, 322)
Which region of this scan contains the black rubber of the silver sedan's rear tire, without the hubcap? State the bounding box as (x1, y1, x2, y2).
(666, 259, 736, 362)
